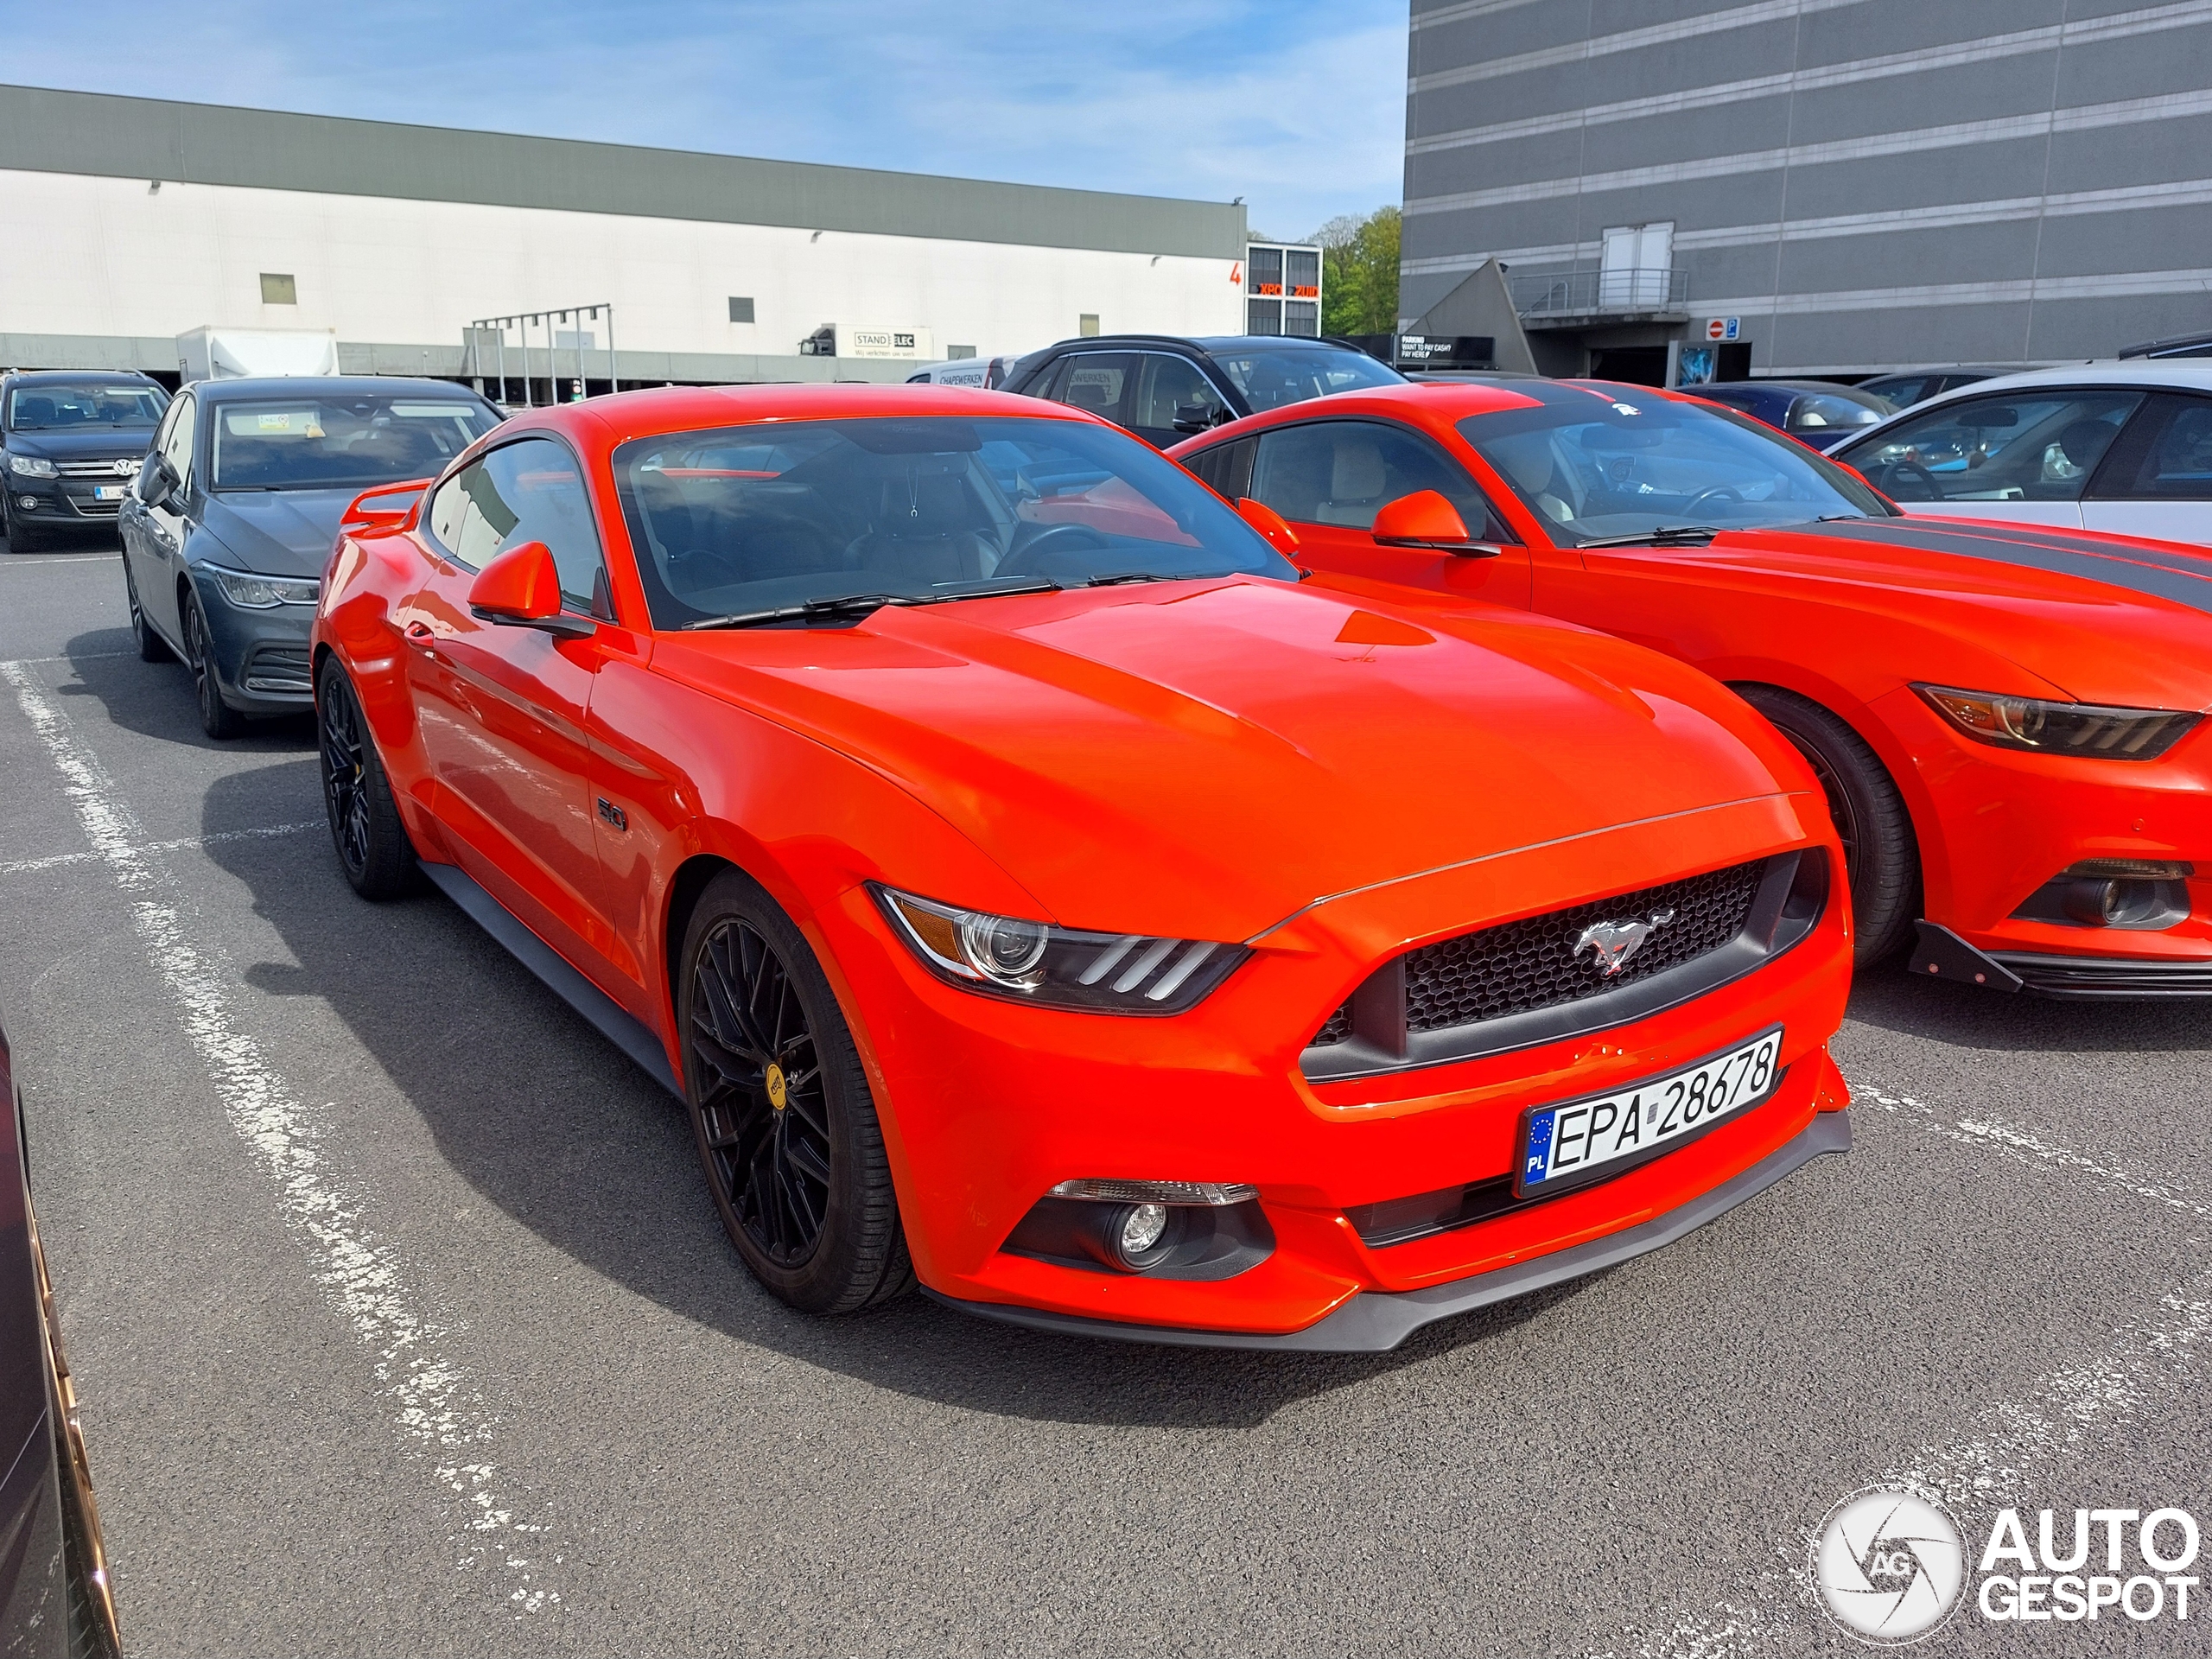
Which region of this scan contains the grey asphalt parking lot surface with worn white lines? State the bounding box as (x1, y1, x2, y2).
(0, 546, 2212, 1659)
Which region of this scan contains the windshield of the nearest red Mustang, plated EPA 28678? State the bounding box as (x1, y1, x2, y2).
(615, 418, 1296, 628)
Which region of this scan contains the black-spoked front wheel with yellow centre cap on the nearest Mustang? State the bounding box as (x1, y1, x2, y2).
(677, 869, 913, 1314)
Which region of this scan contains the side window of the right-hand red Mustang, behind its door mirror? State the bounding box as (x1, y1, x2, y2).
(1248, 420, 1513, 542)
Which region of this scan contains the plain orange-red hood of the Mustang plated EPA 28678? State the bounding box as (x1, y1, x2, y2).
(655, 577, 1802, 940)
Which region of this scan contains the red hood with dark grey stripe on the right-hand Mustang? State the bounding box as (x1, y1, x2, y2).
(1681, 515, 2212, 710)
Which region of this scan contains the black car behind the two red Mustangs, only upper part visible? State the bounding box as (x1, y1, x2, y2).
(1007, 334, 1405, 449)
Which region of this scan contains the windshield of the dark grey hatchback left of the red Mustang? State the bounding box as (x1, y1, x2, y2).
(208, 391, 500, 489)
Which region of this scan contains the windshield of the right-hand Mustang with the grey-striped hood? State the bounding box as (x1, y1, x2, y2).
(1460, 387, 1889, 546)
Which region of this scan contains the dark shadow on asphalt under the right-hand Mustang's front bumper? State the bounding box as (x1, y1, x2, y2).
(1849, 964, 2212, 1053)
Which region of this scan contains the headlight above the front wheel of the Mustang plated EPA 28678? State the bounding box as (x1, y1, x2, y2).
(869, 882, 1249, 1013)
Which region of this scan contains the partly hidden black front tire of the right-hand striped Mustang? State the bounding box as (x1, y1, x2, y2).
(1737, 686, 1920, 967)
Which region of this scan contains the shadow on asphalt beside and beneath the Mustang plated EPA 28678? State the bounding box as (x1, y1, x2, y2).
(204, 759, 1592, 1427)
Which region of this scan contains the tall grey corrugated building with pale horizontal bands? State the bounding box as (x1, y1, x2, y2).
(1400, 0, 2212, 378)
